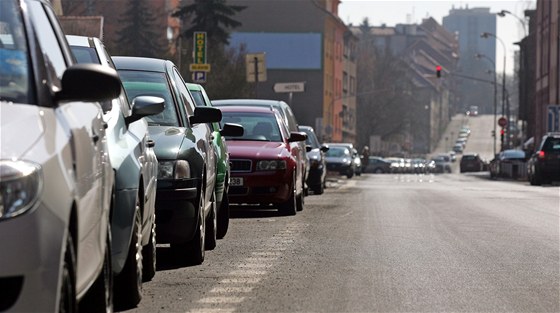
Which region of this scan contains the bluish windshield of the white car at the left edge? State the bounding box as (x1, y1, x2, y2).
(0, 1, 32, 103)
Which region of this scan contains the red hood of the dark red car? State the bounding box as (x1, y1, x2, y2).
(227, 140, 286, 159)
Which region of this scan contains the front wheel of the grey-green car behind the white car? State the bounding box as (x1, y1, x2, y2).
(115, 208, 143, 310)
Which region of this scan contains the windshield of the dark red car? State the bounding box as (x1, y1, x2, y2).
(221, 112, 283, 142)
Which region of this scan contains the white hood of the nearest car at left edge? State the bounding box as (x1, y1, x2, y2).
(0, 103, 46, 159)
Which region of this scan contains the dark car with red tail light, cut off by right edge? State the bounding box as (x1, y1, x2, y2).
(527, 133, 560, 185)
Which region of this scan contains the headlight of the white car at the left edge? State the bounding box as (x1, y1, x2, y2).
(0, 161, 43, 220)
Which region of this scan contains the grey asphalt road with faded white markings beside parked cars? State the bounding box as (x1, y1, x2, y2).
(124, 173, 560, 313)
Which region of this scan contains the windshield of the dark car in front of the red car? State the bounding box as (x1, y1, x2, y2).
(119, 70, 179, 126)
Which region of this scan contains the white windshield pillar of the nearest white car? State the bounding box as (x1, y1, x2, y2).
(28, 1, 67, 88)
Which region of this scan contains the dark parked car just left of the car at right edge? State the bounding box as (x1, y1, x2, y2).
(489, 149, 527, 178)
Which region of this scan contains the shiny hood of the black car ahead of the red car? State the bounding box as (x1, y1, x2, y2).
(148, 126, 188, 160)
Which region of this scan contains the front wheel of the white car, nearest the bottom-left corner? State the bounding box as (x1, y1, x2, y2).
(58, 231, 78, 313)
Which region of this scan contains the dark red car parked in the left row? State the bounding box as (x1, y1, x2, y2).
(220, 106, 307, 215)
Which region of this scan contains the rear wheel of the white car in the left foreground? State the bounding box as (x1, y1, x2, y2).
(80, 225, 113, 313)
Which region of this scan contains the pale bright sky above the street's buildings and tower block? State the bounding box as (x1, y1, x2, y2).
(338, 0, 536, 73)
